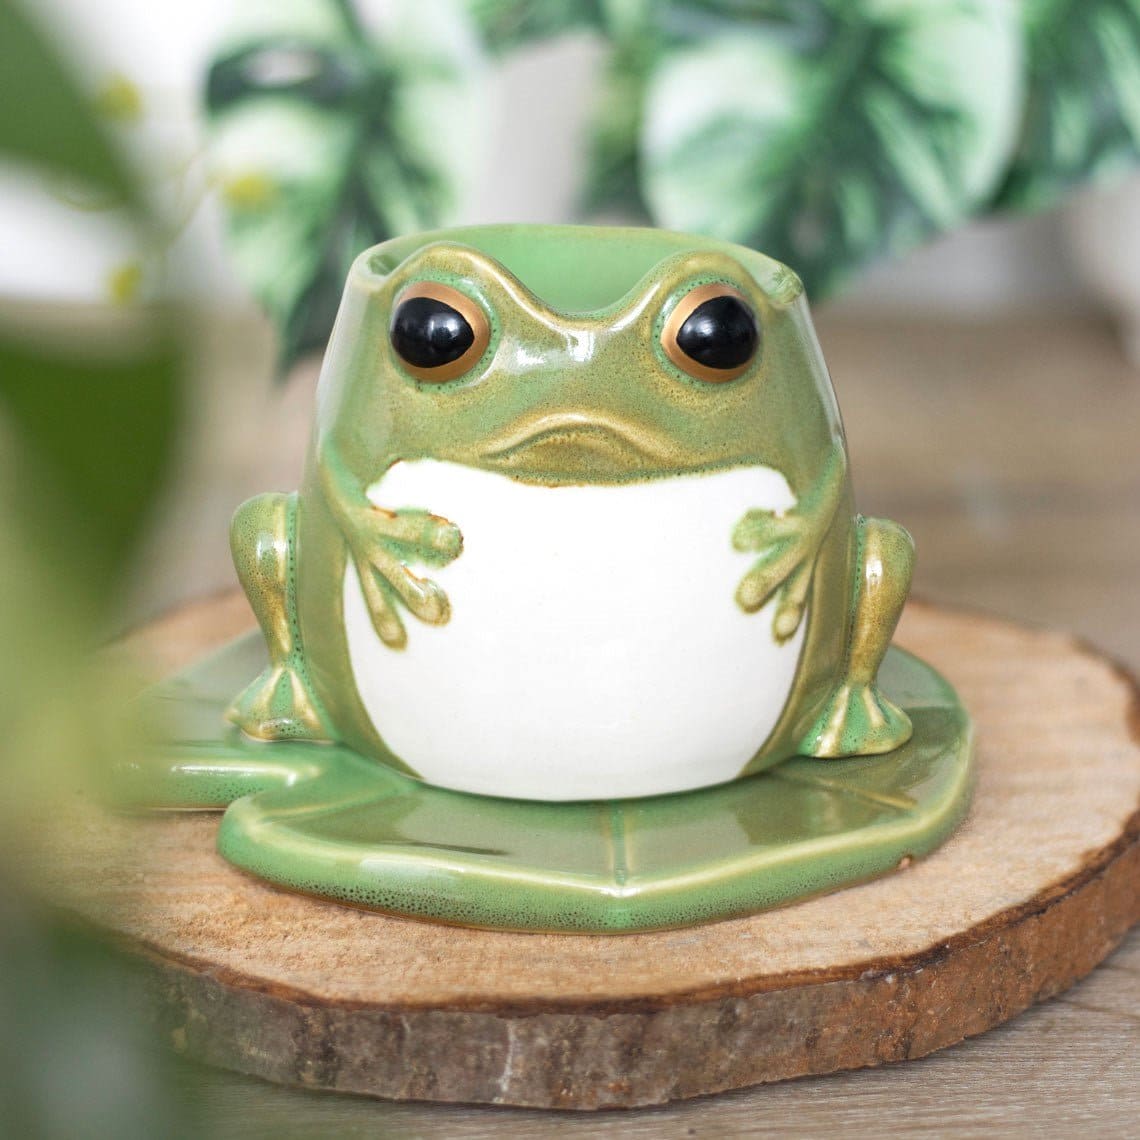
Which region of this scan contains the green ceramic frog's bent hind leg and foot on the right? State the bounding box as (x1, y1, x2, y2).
(800, 516, 914, 759)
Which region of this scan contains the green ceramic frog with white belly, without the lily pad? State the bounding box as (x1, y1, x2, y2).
(229, 226, 913, 799)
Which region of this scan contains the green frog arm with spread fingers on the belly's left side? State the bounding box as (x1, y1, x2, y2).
(317, 442, 463, 649)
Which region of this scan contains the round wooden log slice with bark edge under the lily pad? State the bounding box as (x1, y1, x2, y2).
(31, 596, 1140, 1109)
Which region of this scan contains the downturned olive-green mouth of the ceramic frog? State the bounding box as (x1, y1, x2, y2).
(485, 412, 670, 482)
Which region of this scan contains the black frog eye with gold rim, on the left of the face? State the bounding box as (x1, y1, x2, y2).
(389, 282, 490, 383)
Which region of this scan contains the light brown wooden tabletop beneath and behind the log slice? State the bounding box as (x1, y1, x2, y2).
(166, 316, 1140, 1138)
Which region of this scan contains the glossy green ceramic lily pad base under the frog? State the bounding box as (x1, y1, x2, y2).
(117, 634, 974, 933)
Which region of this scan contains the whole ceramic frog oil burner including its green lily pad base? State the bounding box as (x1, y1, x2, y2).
(123, 226, 972, 930)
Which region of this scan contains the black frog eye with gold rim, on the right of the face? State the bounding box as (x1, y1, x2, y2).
(661, 284, 760, 384)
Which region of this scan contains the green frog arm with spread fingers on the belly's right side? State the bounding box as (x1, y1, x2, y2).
(732, 443, 847, 644)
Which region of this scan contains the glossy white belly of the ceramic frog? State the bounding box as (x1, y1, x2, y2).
(344, 461, 806, 799)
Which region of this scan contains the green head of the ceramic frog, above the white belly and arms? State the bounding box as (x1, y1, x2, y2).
(317, 226, 841, 486)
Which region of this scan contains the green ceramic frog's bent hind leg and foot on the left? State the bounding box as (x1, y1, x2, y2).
(226, 494, 332, 741)
